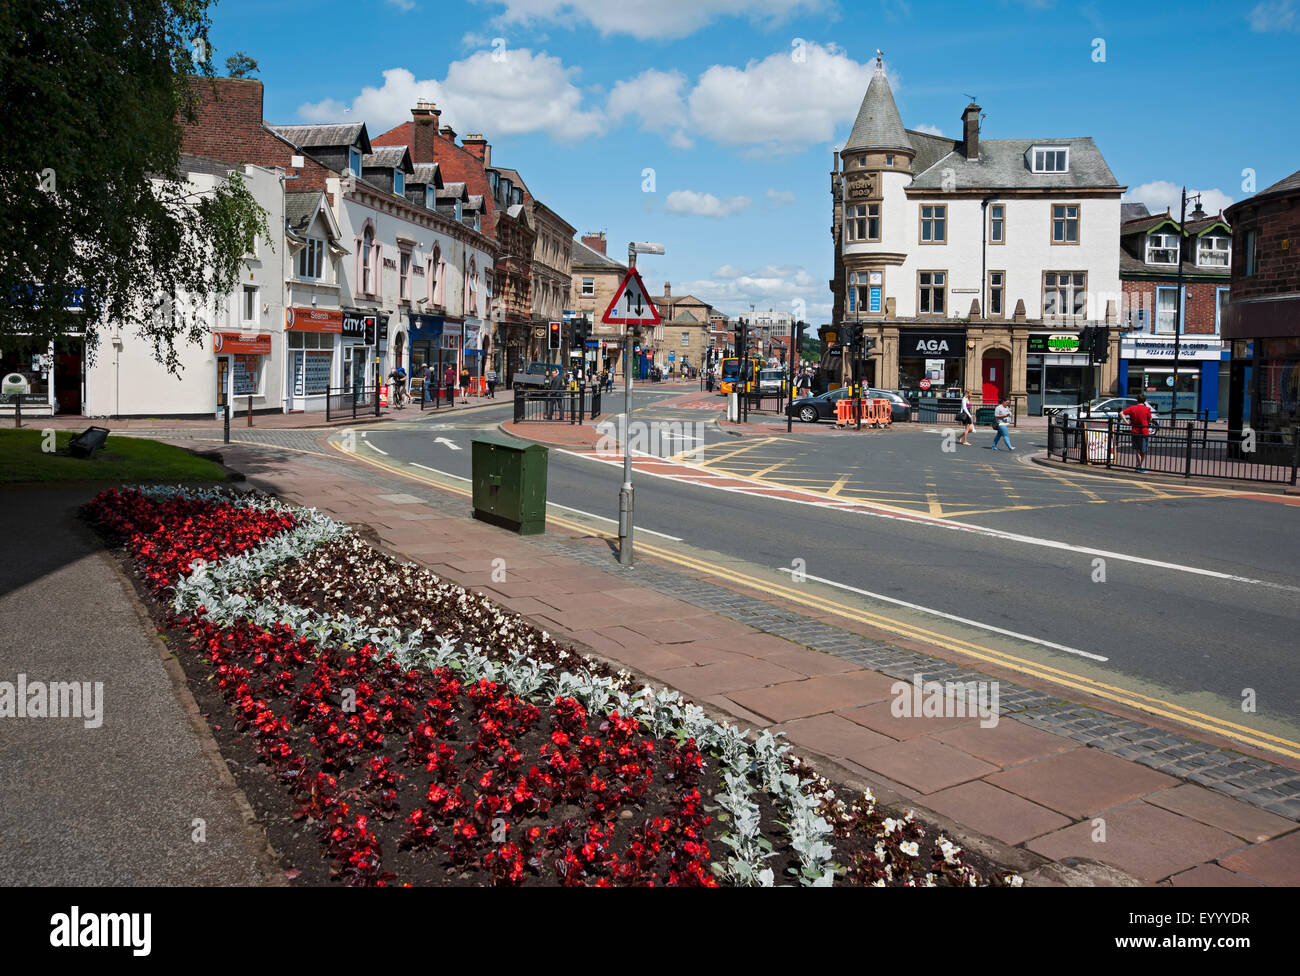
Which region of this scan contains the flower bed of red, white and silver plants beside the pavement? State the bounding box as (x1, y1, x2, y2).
(87, 489, 1019, 886)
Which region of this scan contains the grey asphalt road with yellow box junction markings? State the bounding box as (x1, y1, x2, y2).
(343, 389, 1300, 741)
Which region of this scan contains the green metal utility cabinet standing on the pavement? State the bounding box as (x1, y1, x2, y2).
(471, 434, 549, 535)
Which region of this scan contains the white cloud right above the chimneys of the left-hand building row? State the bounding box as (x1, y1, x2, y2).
(298, 48, 605, 140)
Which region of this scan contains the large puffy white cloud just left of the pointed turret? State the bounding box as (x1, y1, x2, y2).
(688, 43, 872, 151)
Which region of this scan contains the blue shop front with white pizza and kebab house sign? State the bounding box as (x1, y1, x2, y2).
(1119, 335, 1223, 420)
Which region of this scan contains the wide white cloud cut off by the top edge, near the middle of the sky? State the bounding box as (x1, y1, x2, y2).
(480, 0, 826, 40)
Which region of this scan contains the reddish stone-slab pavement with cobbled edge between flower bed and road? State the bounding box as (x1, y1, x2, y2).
(205, 446, 1300, 885)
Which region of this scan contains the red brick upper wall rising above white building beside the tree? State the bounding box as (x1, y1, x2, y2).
(181, 78, 333, 192)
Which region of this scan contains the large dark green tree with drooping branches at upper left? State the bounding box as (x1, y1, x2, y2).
(0, 0, 267, 369)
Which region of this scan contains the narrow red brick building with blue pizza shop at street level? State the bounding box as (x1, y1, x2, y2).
(1118, 204, 1232, 420)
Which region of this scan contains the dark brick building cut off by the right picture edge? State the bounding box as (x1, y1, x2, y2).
(1223, 170, 1300, 439)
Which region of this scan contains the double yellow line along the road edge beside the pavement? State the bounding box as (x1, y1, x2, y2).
(330, 442, 1300, 759)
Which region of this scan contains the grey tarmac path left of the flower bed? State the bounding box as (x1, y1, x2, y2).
(0, 485, 283, 886)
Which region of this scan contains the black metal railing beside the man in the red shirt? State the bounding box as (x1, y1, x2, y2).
(1048, 417, 1300, 485)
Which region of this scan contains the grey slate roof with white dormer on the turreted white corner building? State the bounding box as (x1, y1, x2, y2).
(907, 135, 1123, 190)
